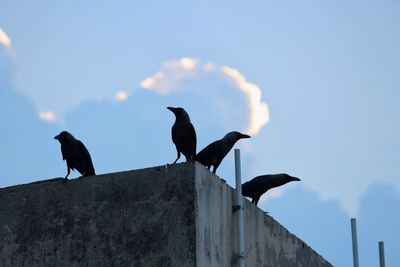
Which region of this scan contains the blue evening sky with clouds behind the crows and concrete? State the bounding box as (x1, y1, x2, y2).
(0, 0, 400, 266)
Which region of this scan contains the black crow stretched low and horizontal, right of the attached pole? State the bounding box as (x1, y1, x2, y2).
(242, 173, 301, 206)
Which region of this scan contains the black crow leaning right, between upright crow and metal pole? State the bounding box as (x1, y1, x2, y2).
(195, 131, 250, 173)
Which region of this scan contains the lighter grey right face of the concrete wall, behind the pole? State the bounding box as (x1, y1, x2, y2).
(195, 165, 332, 267)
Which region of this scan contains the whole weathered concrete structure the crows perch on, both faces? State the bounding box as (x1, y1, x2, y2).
(0, 163, 331, 266)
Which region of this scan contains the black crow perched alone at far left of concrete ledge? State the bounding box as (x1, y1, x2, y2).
(54, 131, 96, 179)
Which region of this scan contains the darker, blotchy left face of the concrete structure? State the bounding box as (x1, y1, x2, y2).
(0, 165, 196, 266)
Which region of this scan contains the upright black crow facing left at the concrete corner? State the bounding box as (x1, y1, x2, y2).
(167, 107, 197, 163)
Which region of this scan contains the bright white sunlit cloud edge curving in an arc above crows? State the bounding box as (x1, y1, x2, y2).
(140, 57, 269, 135)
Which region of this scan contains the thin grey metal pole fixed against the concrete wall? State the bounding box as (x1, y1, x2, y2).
(235, 149, 245, 267)
